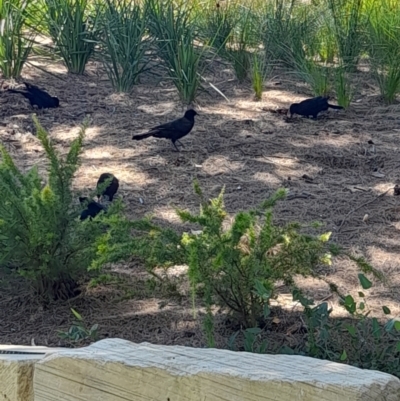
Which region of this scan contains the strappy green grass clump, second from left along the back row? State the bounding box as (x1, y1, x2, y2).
(45, 0, 99, 74)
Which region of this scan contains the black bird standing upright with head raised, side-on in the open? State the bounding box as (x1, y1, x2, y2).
(132, 109, 198, 152)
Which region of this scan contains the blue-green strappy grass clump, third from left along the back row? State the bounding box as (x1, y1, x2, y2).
(97, 0, 151, 92)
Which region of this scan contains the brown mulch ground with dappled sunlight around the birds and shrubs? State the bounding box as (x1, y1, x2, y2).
(0, 55, 400, 347)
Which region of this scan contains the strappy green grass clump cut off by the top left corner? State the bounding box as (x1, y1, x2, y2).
(0, 0, 36, 78)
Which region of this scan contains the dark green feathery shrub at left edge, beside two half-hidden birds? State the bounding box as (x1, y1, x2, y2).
(0, 117, 117, 299)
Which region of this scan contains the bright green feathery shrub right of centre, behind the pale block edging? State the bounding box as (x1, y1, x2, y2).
(178, 184, 330, 346)
